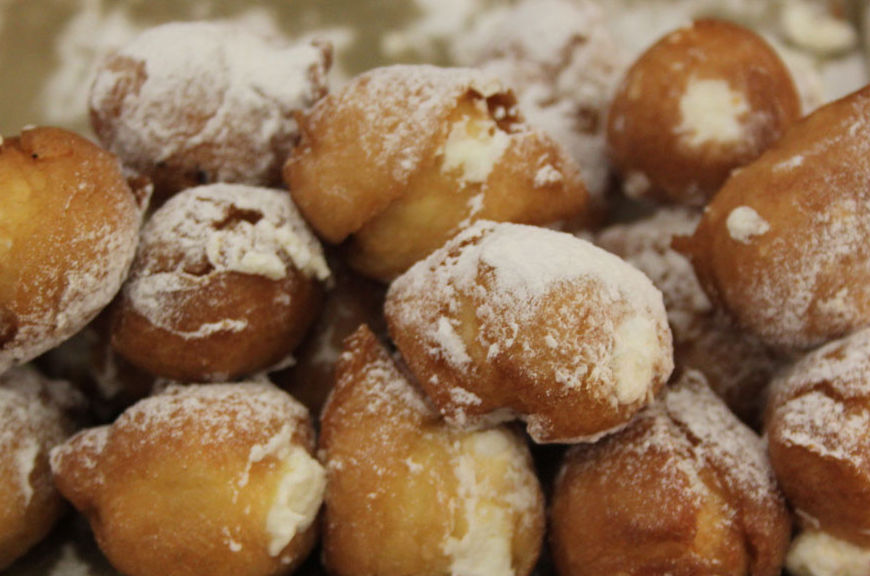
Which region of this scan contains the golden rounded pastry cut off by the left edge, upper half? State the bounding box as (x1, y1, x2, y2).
(0, 128, 140, 373)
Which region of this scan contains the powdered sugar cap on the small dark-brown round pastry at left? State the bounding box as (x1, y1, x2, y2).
(124, 184, 329, 338)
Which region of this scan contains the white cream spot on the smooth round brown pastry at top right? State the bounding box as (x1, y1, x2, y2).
(676, 79, 749, 148)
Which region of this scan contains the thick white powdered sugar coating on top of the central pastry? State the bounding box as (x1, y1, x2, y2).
(387, 221, 668, 432)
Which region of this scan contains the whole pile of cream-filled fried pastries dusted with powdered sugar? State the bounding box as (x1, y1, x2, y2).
(0, 0, 870, 576)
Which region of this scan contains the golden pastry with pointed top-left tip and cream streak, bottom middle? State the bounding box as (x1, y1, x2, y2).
(320, 326, 544, 576)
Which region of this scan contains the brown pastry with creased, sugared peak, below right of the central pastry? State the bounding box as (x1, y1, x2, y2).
(550, 371, 791, 576)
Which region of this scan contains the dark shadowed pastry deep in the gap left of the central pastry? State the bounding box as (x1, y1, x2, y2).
(282, 257, 387, 414)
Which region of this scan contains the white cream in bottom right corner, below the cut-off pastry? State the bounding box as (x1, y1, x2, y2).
(785, 531, 870, 576)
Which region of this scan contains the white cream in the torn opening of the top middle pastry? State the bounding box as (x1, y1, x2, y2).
(442, 102, 510, 184)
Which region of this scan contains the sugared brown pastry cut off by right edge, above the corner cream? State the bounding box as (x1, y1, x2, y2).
(765, 330, 870, 547)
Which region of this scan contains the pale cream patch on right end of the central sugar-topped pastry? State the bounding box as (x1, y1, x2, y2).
(611, 316, 660, 404)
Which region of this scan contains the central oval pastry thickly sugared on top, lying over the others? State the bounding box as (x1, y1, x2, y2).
(385, 221, 673, 443)
